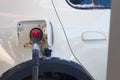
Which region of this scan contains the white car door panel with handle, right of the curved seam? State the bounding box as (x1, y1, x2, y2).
(53, 0, 111, 80)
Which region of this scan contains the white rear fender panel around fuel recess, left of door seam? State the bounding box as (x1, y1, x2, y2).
(0, 0, 75, 75)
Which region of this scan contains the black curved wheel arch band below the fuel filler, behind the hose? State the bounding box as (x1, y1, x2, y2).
(0, 58, 94, 80)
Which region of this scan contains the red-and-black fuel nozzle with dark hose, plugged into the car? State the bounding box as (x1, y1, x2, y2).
(30, 28, 43, 80)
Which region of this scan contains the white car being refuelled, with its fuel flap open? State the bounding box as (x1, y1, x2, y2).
(0, 0, 111, 80)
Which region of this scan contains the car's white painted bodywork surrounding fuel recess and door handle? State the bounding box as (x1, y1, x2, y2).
(0, 0, 110, 80)
